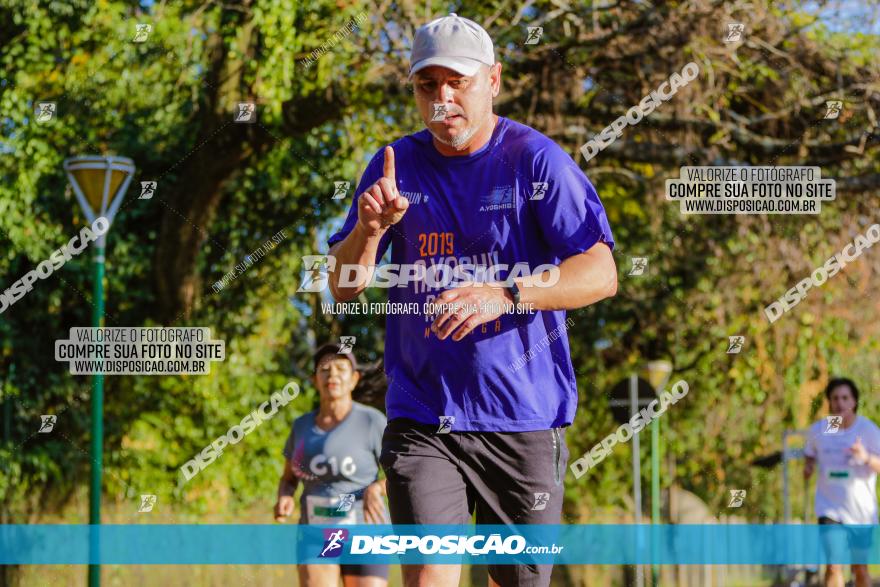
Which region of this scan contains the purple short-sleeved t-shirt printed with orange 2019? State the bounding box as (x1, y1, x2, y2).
(328, 116, 614, 432)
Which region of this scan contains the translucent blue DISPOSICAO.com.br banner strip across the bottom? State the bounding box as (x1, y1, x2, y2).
(0, 524, 880, 565)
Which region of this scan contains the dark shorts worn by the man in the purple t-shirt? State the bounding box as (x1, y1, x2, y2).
(379, 418, 569, 587)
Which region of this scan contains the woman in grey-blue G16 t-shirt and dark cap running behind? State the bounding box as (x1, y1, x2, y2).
(275, 344, 389, 587)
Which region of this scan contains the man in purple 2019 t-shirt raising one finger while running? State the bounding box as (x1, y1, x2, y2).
(328, 14, 617, 587)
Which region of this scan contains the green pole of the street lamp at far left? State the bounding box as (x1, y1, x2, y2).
(89, 243, 104, 587)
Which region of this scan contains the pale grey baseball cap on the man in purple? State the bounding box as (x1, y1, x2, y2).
(409, 12, 495, 78)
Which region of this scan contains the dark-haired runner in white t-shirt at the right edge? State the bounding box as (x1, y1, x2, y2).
(804, 378, 880, 587)
